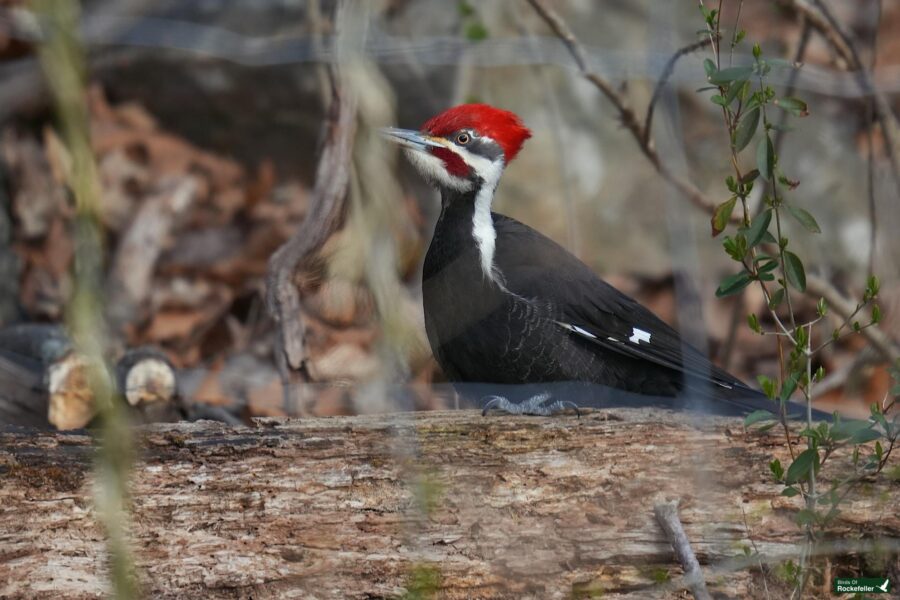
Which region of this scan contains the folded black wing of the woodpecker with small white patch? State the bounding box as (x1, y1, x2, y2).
(494, 214, 750, 389)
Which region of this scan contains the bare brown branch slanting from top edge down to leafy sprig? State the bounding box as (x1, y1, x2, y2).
(528, 0, 716, 220)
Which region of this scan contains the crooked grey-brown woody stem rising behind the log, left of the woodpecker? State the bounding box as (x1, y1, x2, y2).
(266, 65, 356, 409)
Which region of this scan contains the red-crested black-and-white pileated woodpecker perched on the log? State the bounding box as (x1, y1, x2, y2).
(384, 104, 808, 414)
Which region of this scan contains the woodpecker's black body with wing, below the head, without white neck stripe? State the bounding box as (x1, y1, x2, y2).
(422, 185, 753, 406)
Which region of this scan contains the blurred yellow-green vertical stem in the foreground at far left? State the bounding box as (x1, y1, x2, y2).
(33, 0, 137, 598)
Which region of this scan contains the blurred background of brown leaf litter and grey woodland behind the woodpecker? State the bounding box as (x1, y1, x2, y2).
(0, 0, 900, 426)
